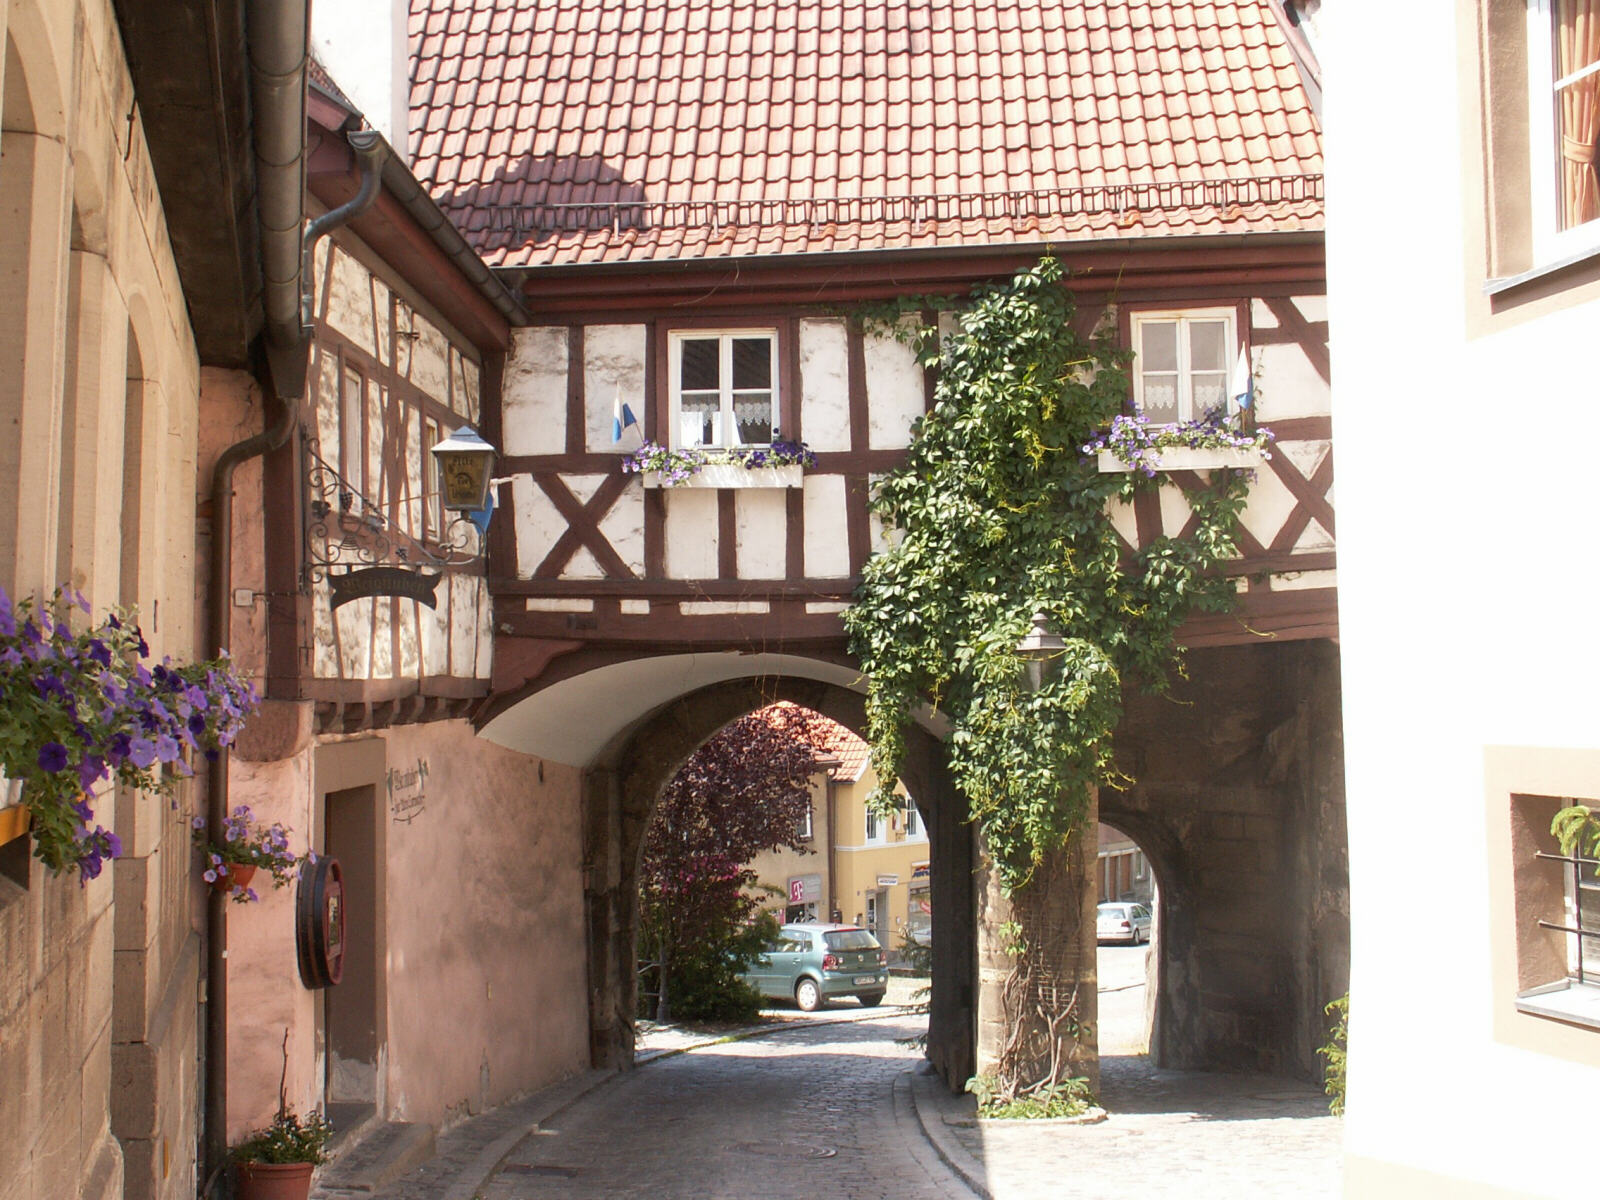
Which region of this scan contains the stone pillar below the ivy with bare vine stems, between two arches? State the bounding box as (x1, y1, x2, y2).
(978, 797, 1099, 1099)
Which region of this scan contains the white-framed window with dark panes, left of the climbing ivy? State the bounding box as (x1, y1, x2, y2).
(667, 330, 778, 450)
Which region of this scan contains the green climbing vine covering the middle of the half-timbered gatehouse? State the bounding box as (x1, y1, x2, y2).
(845, 259, 1248, 893)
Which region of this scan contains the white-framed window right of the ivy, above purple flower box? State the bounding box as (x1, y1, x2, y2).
(1133, 309, 1238, 424)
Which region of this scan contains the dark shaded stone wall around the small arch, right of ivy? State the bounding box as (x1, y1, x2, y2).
(1101, 642, 1349, 1078)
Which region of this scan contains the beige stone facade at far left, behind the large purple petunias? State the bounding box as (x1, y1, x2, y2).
(0, 0, 200, 1200)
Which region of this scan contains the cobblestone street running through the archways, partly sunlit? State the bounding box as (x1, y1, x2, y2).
(331, 947, 1341, 1200)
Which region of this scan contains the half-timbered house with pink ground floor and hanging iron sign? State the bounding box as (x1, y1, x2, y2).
(208, 62, 587, 1154)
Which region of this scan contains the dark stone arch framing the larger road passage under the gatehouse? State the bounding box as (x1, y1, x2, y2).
(582, 677, 976, 1088)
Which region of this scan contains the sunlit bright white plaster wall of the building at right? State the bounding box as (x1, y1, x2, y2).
(1322, 0, 1600, 1197)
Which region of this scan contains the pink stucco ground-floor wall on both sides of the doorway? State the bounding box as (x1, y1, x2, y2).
(217, 722, 589, 1138)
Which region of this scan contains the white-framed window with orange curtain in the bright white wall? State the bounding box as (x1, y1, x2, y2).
(1528, 0, 1600, 262)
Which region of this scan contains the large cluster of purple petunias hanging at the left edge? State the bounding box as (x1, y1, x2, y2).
(0, 587, 258, 883)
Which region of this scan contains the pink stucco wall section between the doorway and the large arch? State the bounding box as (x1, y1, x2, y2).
(376, 722, 589, 1125)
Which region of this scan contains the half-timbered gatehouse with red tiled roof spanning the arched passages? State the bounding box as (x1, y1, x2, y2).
(411, 0, 1346, 1085)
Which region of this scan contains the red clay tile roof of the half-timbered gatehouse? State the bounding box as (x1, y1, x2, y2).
(411, 0, 1322, 266)
